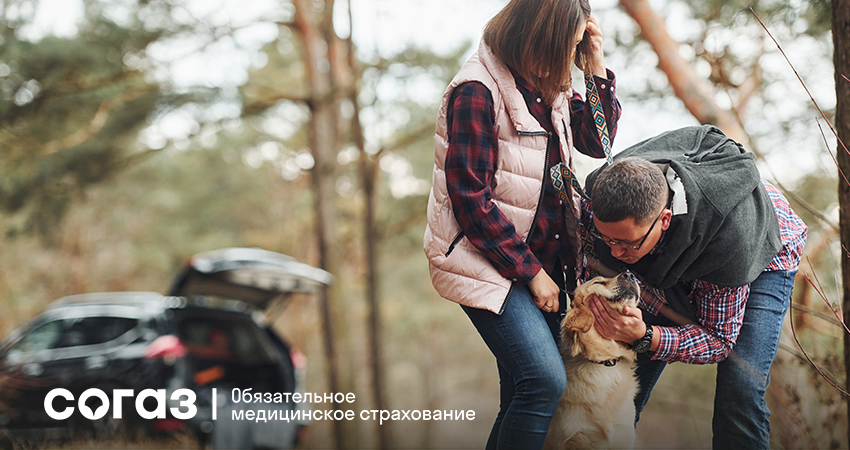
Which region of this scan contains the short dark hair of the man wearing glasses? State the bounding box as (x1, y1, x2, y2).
(590, 157, 668, 225)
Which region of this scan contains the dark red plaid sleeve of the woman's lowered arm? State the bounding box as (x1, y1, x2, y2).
(445, 82, 542, 284)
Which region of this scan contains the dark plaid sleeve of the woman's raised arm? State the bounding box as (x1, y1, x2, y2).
(570, 70, 622, 158)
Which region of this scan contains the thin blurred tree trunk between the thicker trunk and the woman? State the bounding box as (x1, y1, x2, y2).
(348, 5, 391, 449)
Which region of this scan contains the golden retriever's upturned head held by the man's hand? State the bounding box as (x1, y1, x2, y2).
(561, 272, 640, 361)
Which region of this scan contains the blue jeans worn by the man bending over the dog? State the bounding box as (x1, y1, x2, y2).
(635, 271, 797, 450)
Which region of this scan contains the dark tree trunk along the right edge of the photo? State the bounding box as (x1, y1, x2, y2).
(832, 0, 850, 441)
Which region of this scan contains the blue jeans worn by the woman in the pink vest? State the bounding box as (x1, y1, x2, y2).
(462, 286, 567, 450)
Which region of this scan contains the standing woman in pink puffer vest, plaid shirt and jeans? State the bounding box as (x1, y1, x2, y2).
(424, 0, 620, 449)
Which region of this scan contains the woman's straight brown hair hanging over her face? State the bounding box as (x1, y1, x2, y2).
(484, 0, 590, 105)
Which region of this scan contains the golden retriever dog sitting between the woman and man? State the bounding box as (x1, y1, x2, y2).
(544, 272, 640, 449)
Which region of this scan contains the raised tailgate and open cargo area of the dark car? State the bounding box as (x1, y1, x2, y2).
(168, 248, 333, 402)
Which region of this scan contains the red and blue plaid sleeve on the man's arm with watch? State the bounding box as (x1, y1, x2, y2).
(652, 280, 750, 364)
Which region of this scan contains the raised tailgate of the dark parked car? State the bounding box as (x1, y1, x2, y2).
(168, 248, 333, 309)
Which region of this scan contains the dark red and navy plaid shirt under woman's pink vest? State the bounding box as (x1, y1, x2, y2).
(445, 71, 620, 288)
